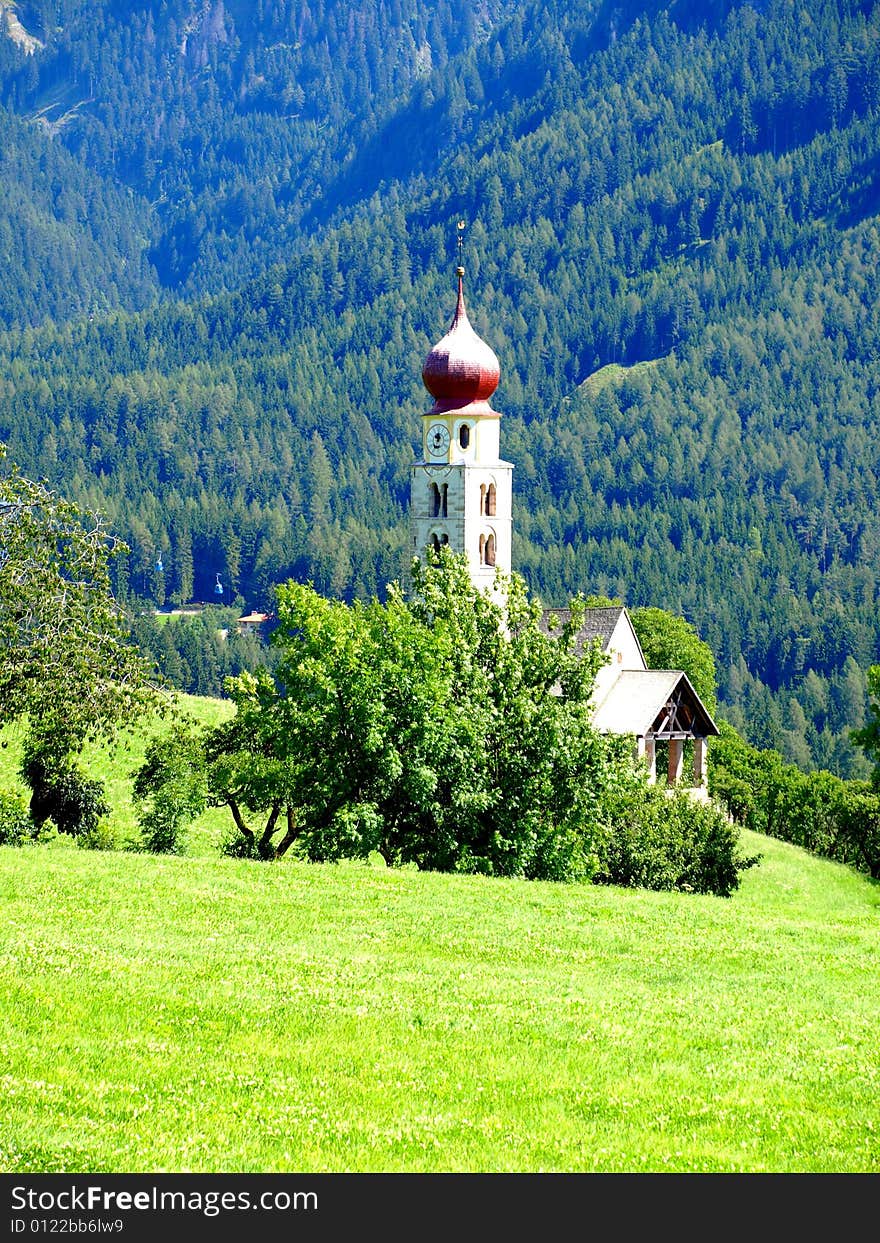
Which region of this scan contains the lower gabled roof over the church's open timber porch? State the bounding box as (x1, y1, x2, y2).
(593, 669, 718, 738)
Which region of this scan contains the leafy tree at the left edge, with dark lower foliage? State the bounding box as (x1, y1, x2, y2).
(0, 446, 153, 833)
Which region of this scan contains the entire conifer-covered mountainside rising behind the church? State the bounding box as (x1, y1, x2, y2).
(0, 0, 880, 773)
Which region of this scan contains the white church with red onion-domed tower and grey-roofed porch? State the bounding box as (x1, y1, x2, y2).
(410, 266, 718, 797)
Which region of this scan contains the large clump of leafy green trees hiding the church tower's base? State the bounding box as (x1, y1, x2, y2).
(205, 554, 635, 879)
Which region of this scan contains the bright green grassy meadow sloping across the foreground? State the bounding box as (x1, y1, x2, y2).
(0, 704, 880, 1172)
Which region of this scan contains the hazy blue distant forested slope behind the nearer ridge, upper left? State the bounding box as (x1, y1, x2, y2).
(0, 0, 517, 308)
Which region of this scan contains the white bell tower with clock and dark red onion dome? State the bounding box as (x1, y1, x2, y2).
(410, 259, 513, 593)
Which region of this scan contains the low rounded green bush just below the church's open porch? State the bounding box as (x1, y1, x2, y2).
(595, 787, 759, 897)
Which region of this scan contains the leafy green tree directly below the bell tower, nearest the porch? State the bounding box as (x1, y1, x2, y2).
(397, 552, 618, 880)
